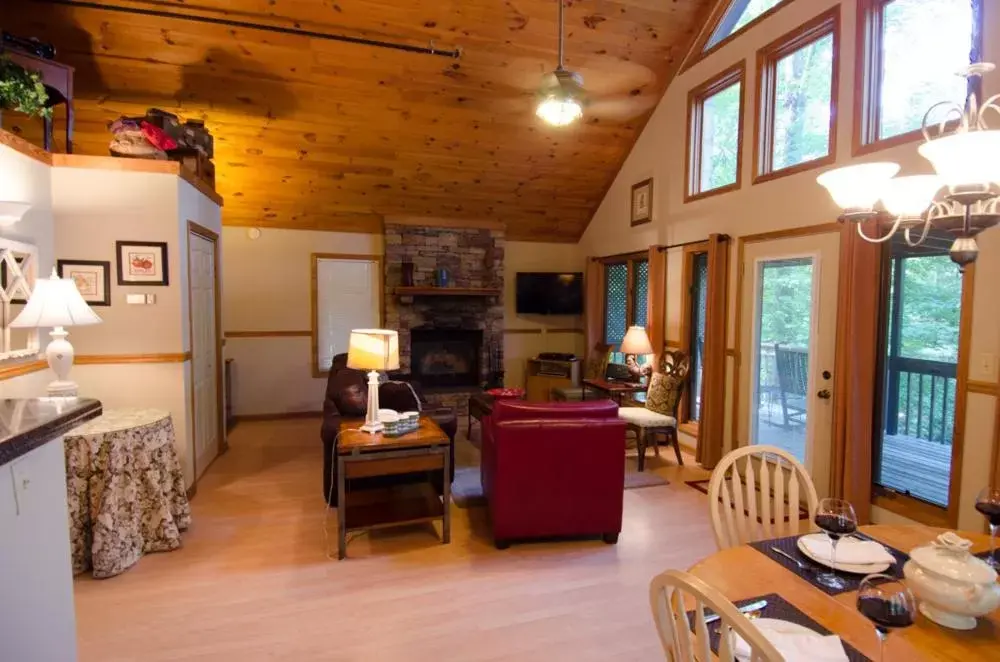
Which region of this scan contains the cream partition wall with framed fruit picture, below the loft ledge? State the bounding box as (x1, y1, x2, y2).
(52, 167, 222, 487)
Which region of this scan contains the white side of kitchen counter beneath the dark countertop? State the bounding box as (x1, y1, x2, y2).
(0, 438, 76, 662)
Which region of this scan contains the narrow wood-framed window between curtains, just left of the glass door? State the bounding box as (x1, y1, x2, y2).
(679, 242, 708, 426)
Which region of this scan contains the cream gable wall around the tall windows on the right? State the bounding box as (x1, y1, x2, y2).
(580, 0, 1000, 530)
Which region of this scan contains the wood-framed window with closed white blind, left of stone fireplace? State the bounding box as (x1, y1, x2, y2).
(316, 258, 382, 371)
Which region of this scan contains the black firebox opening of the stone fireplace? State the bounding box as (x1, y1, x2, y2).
(410, 328, 483, 388)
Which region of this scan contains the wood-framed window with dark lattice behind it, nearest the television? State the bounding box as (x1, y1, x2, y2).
(604, 251, 649, 363)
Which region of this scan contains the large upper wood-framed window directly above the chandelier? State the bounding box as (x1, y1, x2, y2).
(853, 0, 982, 155)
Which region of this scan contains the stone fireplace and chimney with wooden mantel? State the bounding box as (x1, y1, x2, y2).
(384, 222, 504, 413)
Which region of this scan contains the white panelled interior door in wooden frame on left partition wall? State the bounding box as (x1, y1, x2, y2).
(188, 232, 220, 479)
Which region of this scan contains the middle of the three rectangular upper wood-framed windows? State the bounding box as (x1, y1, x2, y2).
(754, 5, 840, 184)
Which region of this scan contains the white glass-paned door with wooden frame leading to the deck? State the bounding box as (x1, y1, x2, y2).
(736, 232, 840, 497)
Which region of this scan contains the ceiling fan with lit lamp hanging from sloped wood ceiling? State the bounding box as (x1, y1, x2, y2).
(535, 0, 656, 126)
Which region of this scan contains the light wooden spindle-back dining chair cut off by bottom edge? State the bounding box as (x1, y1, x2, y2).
(649, 570, 783, 662)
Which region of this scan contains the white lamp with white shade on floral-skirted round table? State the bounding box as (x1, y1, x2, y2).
(10, 269, 101, 396)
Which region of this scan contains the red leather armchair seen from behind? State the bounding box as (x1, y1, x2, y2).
(481, 400, 625, 549)
